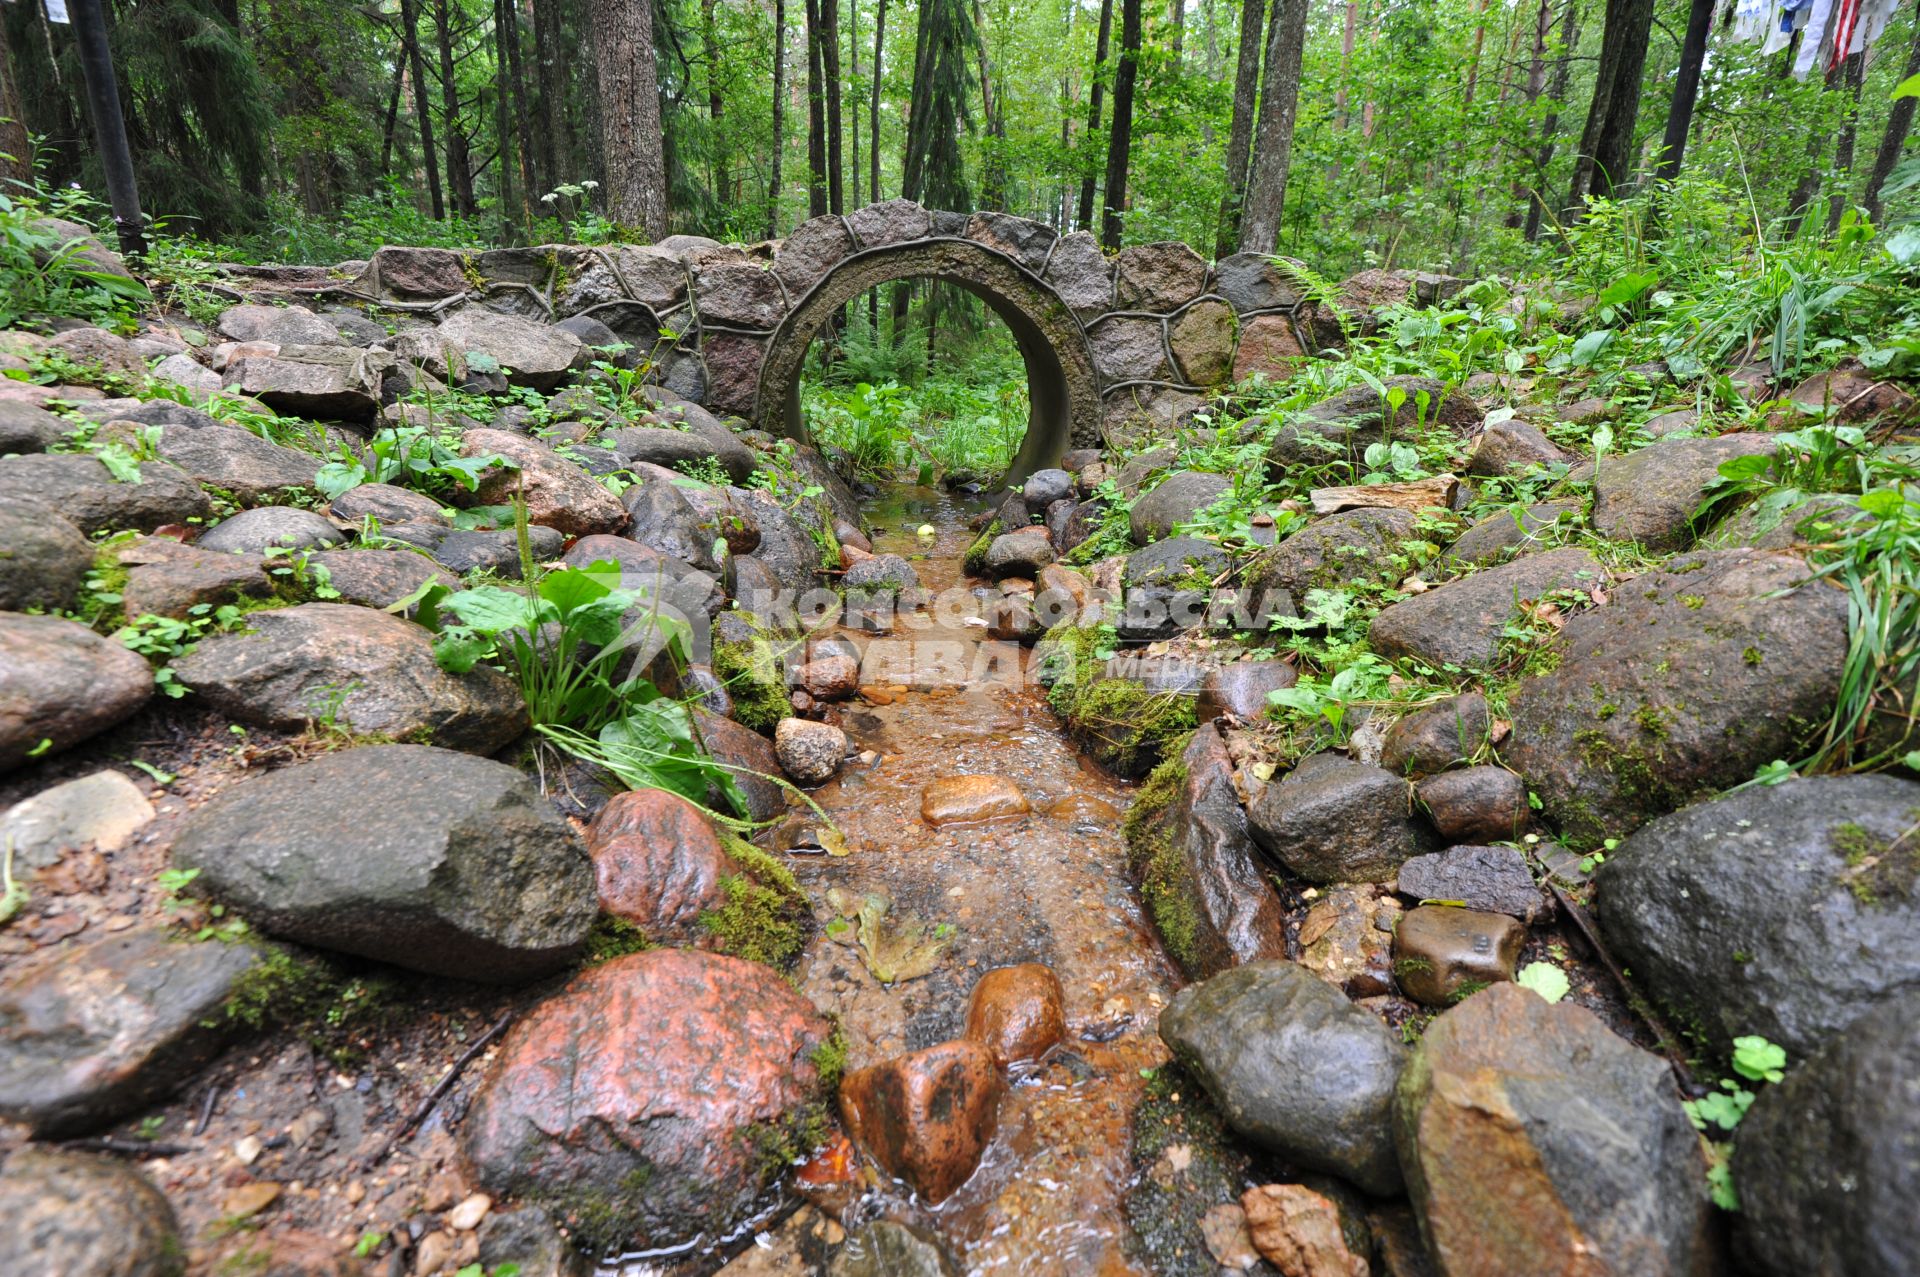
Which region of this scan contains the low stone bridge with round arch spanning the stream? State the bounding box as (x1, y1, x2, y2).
(332, 200, 1338, 476)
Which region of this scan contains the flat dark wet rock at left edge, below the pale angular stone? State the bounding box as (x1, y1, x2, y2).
(0, 928, 265, 1139)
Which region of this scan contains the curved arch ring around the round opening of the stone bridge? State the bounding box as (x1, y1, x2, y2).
(753, 238, 1100, 482)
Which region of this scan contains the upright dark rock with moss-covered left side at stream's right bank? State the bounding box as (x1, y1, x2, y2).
(1127, 724, 1286, 979)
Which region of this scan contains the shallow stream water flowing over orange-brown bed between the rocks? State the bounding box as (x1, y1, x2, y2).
(775, 488, 1175, 1277)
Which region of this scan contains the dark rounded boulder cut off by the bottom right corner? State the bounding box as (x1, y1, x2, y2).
(1734, 993, 1920, 1277)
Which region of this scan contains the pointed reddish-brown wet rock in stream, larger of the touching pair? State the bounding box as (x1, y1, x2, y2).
(841, 1039, 1000, 1206)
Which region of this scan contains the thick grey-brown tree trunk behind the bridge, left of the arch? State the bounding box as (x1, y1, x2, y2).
(588, 0, 666, 240)
